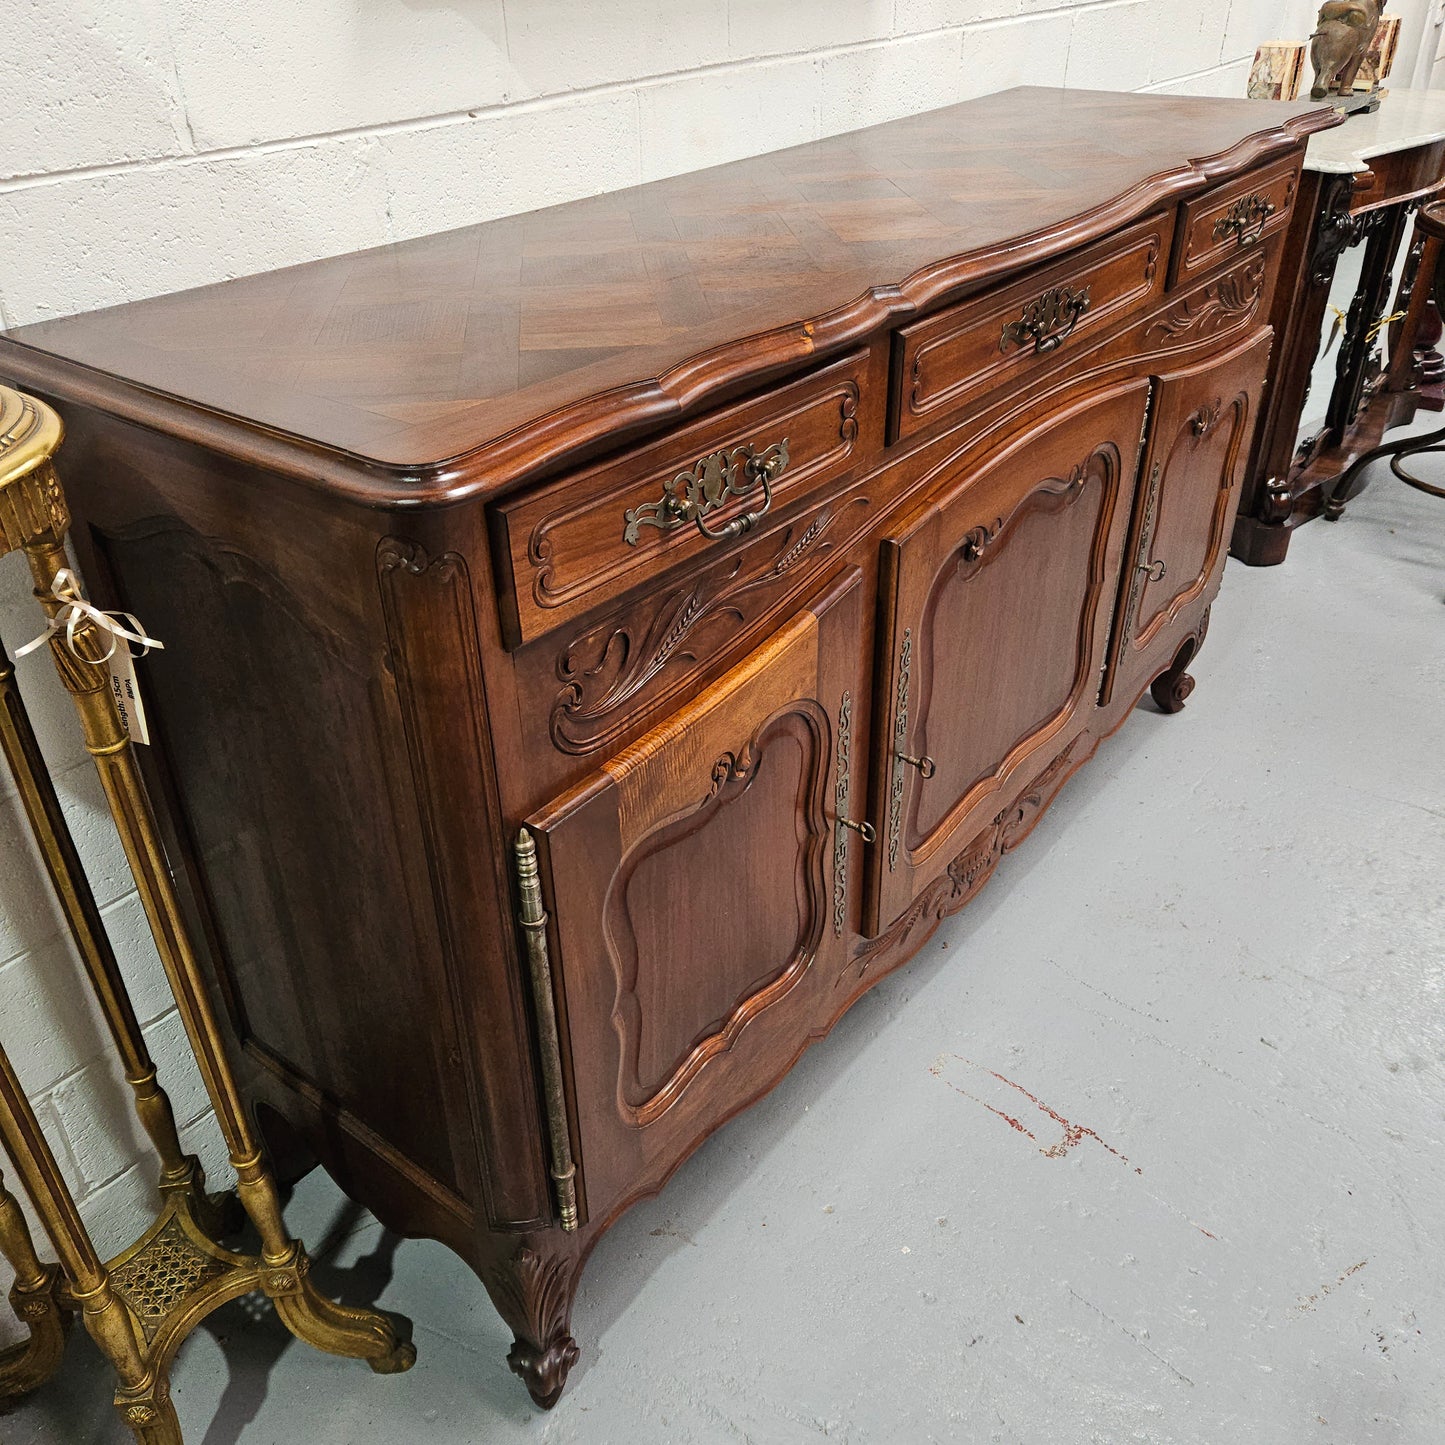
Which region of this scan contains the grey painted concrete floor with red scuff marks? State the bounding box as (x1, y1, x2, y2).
(0, 458, 1445, 1445)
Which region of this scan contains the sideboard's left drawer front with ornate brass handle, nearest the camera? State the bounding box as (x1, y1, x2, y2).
(493, 351, 883, 647)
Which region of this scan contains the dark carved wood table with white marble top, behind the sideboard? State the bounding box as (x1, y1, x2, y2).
(1231, 91, 1445, 566)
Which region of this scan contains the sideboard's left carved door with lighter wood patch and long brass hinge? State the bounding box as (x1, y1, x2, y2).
(529, 568, 867, 1220)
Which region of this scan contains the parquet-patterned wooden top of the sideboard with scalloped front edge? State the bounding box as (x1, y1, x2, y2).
(0, 88, 1338, 506)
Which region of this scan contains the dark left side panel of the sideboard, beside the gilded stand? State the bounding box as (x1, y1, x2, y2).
(38, 407, 497, 1233)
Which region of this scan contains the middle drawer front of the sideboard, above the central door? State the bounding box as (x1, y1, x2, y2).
(890, 215, 1173, 441)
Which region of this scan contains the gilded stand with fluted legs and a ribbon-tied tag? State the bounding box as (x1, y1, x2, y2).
(0, 387, 416, 1445)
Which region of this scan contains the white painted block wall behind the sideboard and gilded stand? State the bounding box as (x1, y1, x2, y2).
(0, 0, 1425, 1338)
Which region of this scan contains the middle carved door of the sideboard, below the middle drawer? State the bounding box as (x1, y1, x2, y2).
(866, 379, 1149, 932)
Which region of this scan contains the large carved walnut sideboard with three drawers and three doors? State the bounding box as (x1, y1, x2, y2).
(0, 90, 1335, 1405)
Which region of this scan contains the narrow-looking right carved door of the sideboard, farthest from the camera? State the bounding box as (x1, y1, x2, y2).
(1100, 331, 1273, 705)
